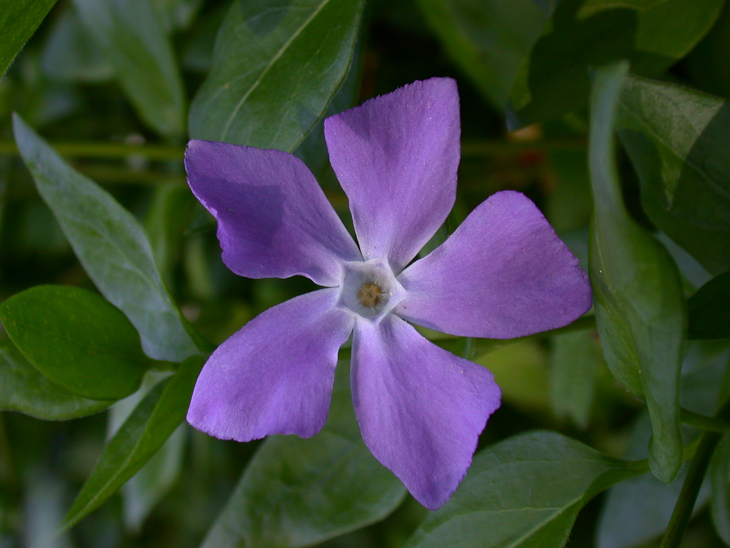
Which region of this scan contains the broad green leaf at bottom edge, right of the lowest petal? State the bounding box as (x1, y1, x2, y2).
(406, 431, 645, 548)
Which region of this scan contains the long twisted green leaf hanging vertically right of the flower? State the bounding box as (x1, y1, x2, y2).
(589, 63, 686, 482)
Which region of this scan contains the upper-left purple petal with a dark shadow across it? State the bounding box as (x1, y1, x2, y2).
(185, 141, 361, 286)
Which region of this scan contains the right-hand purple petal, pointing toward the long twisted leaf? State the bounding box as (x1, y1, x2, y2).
(394, 191, 591, 339)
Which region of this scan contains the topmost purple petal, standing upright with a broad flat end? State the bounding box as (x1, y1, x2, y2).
(324, 78, 460, 272)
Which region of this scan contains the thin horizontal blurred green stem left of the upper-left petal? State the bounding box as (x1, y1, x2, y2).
(0, 141, 185, 160)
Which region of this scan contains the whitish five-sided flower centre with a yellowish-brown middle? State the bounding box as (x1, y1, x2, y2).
(340, 259, 405, 322)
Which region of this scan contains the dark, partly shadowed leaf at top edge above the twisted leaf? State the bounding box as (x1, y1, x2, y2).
(508, 0, 723, 129)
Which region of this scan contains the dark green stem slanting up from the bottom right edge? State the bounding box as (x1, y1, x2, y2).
(660, 402, 730, 548)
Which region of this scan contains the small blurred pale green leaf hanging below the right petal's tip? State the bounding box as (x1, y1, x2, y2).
(550, 329, 601, 429)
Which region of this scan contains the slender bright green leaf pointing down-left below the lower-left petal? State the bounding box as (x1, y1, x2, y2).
(62, 356, 204, 528)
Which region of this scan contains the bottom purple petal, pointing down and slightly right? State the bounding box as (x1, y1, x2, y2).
(351, 315, 500, 510)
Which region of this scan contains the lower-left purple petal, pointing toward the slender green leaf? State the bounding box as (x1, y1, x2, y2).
(187, 289, 354, 441)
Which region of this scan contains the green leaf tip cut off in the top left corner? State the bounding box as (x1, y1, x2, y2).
(0, 0, 56, 78)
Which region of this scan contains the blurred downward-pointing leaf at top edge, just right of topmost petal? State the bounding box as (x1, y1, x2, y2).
(419, 0, 552, 108)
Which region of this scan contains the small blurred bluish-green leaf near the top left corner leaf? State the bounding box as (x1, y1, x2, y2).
(41, 4, 114, 82)
